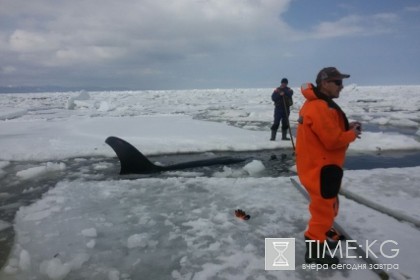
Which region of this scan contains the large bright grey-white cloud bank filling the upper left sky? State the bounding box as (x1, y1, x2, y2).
(1, 0, 289, 66)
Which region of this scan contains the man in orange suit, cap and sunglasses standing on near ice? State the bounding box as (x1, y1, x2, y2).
(296, 67, 361, 264)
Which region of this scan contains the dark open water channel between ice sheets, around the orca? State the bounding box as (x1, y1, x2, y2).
(0, 149, 420, 268)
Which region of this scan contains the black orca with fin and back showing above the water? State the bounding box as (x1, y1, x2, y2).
(105, 136, 248, 175)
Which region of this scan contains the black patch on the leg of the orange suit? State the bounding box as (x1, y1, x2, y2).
(321, 164, 343, 198)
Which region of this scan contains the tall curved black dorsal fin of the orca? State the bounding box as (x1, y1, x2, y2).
(105, 136, 160, 175)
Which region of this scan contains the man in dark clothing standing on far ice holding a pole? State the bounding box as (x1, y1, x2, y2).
(270, 78, 293, 141)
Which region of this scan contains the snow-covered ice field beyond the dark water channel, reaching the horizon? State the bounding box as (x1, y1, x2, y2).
(0, 84, 420, 161)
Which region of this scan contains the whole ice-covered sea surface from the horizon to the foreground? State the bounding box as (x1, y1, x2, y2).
(0, 85, 420, 280)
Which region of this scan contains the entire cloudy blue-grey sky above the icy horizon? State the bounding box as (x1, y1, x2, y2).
(0, 0, 420, 90)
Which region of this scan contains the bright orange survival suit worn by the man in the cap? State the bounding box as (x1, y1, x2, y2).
(296, 83, 356, 242)
